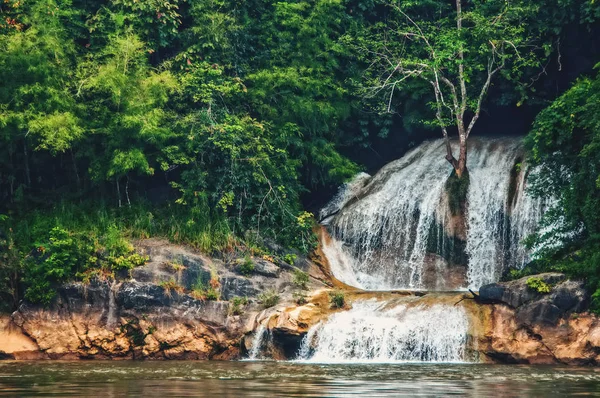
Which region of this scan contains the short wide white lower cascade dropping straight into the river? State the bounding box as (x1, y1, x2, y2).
(298, 300, 469, 362)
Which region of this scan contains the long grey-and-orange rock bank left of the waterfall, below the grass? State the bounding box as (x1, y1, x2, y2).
(0, 240, 322, 359)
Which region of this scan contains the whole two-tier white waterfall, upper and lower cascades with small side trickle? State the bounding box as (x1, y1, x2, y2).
(250, 138, 545, 362)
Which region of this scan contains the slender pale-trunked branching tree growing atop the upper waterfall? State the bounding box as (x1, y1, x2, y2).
(362, 0, 539, 178)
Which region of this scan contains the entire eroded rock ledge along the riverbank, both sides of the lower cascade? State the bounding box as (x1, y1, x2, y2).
(0, 241, 600, 365)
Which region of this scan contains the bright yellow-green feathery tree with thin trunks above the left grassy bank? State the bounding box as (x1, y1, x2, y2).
(79, 33, 177, 207)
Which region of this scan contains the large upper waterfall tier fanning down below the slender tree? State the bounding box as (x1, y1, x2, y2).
(321, 138, 544, 290)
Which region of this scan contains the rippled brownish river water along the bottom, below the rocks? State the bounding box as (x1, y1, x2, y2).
(0, 361, 600, 398)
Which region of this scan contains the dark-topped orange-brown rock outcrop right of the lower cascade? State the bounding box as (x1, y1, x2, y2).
(479, 273, 600, 365)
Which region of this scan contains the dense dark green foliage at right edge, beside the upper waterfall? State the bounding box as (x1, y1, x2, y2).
(528, 67, 600, 309)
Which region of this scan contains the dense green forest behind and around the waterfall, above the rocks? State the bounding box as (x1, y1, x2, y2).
(0, 0, 600, 310)
